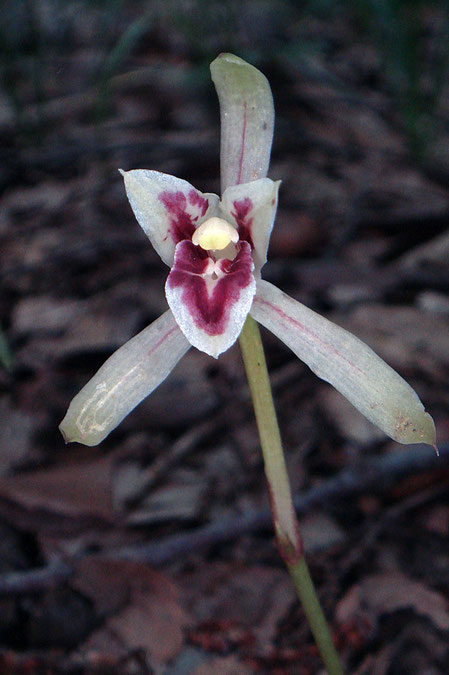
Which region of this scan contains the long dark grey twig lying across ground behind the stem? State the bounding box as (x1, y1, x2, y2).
(0, 444, 449, 597)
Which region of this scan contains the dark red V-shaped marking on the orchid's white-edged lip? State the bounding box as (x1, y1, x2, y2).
(167, 241, 253, 335)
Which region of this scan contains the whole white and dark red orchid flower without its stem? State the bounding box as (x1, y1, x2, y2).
(60, 54, 435, 446)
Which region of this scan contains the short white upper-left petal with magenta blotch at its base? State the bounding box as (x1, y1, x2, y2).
(120, 169, 219, 267)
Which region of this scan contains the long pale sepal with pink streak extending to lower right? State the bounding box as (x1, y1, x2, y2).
(251, 281, 435, 445)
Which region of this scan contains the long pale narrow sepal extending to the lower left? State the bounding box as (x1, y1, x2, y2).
(59, 310, 190, 445)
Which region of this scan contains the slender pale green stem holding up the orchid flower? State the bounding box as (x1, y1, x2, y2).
(240, 316, 344, 675)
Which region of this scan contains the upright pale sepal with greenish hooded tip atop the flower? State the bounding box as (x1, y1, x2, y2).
(210, 54, 274, 192)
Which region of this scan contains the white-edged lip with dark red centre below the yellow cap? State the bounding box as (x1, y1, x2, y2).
(165, 241, 256, 358)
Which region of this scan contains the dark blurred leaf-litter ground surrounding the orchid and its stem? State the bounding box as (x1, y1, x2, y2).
(0, 0, 449, 675)
